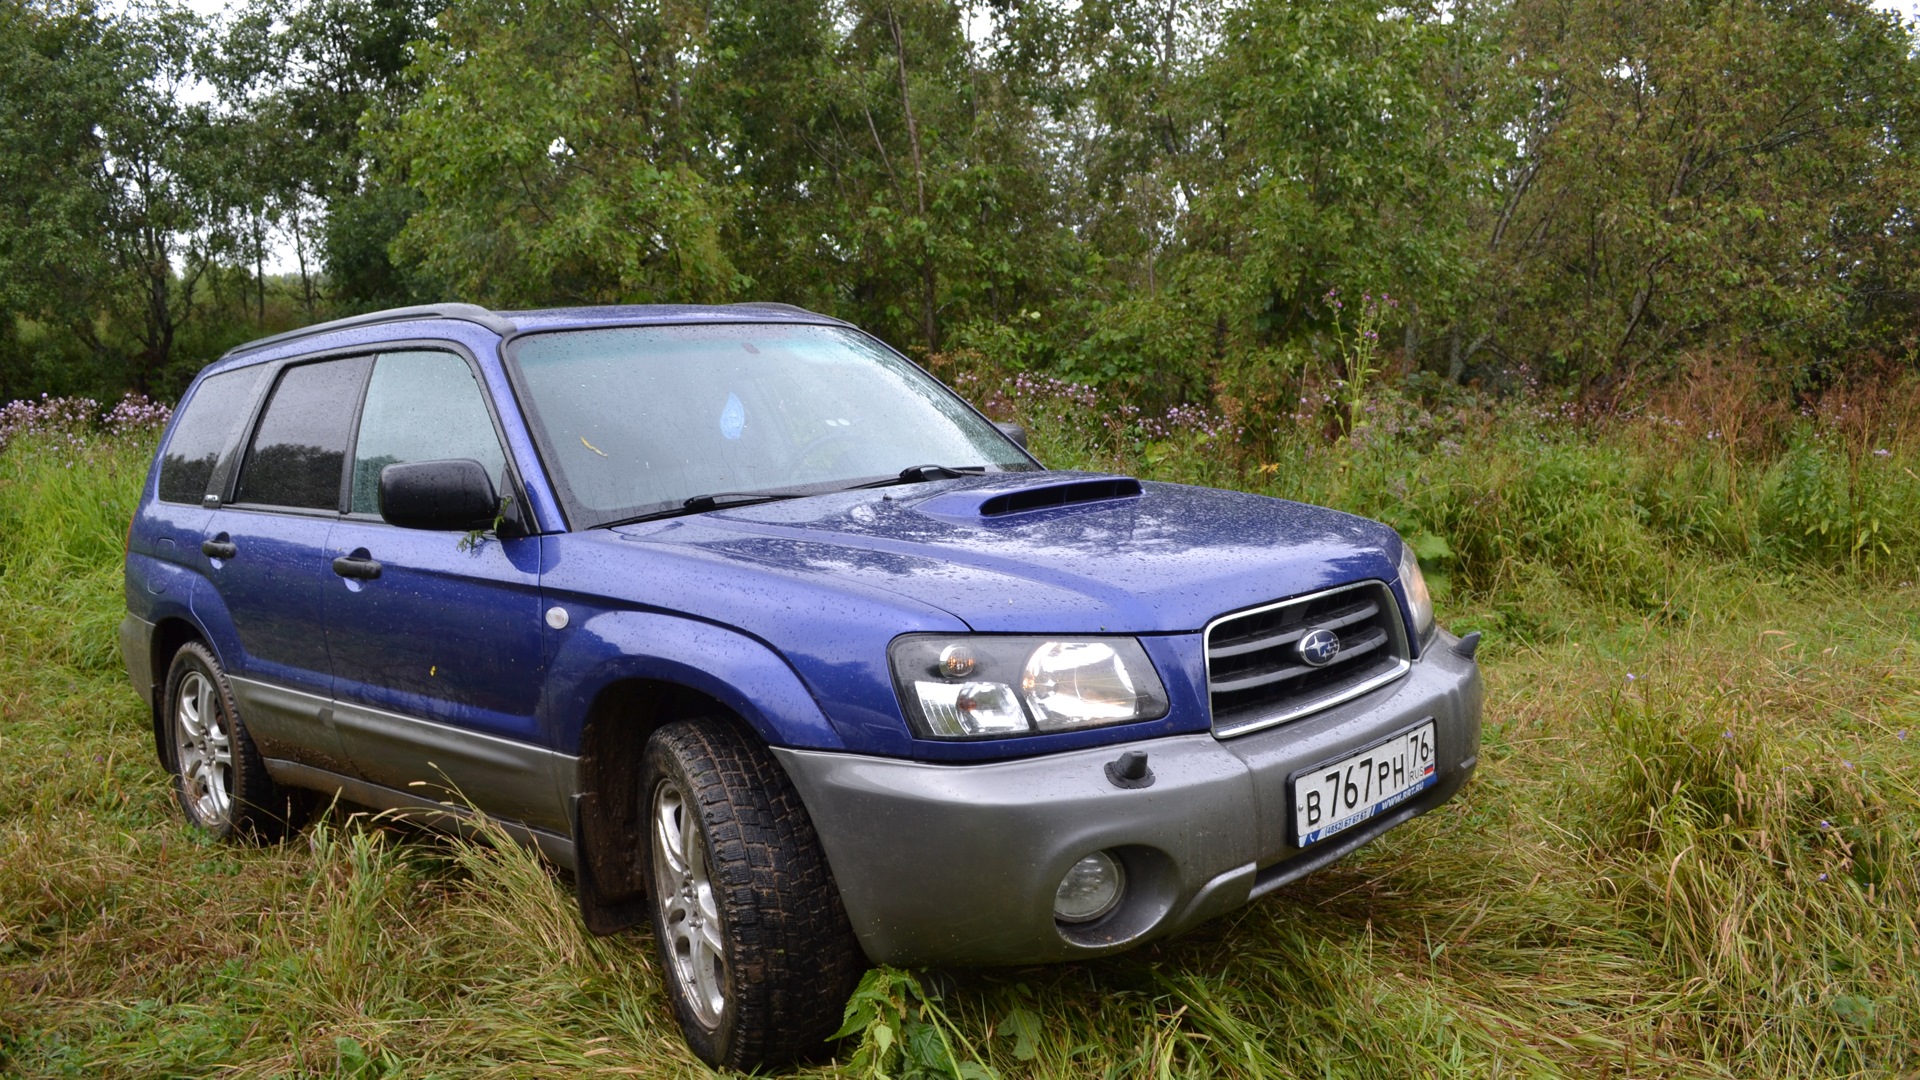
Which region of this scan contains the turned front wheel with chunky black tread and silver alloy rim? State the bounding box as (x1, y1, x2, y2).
(641, 719, 866, 1070)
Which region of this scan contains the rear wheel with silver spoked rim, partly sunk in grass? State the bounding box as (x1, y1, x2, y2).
(161, 642, 311, 842)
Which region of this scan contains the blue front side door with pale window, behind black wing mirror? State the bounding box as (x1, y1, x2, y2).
(326, 348, 566, 832)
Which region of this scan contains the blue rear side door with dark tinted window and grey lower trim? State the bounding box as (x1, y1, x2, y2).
(194, 357, 372, 773)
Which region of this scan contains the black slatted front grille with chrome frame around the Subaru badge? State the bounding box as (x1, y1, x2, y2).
(1206, 580, 1409, 736)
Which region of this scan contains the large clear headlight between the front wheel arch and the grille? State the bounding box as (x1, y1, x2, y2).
(889, 634, 1167, 738)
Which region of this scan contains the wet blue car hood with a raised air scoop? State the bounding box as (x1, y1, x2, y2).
(616, 473, 1400, 632)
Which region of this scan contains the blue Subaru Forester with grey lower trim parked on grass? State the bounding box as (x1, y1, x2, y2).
(121, 304, 1480, 1067)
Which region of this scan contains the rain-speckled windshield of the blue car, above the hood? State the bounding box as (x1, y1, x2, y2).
(511, 323, 1033, 528)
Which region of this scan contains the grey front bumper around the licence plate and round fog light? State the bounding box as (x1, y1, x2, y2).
(774, 634, 1480, 967)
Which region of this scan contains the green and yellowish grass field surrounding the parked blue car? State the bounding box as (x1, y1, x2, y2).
(0, 384, 1920, 1078)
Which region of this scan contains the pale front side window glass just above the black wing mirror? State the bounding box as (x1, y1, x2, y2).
(351, 352, 507, 513)
